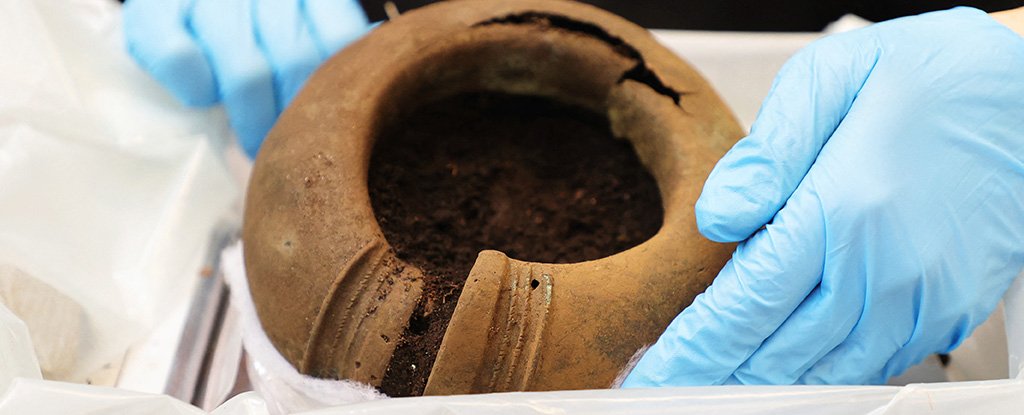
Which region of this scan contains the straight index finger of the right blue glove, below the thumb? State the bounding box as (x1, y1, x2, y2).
(623, 180, 824, 387)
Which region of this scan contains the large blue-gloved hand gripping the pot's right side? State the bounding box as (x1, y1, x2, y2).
(624, 8, 1024, 387)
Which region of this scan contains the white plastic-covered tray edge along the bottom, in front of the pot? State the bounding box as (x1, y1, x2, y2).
(309, 380, 1024, 415)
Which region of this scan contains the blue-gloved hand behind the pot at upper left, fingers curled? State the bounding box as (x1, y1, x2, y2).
(124, 0, 369, 157)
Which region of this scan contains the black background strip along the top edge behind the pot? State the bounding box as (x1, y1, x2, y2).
(360, 0, 1024, 32)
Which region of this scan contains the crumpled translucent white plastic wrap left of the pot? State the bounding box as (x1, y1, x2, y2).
(0, 0, 240, 382)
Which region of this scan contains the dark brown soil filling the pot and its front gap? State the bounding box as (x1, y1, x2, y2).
(369, 93, 663, 397)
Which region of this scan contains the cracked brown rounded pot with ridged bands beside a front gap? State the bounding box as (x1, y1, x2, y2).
(244, 0, 742, 395)
